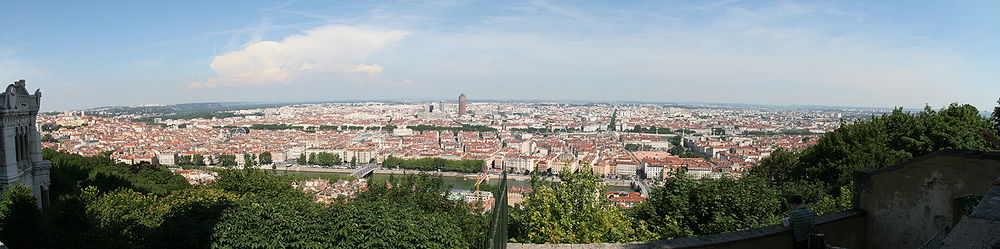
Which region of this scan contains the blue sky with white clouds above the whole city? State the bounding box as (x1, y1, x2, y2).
(0, 0, 1000, 111)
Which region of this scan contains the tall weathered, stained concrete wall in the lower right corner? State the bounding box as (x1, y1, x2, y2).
(855, 150, 1000, 249)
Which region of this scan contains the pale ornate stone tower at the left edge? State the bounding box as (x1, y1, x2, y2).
(0, 80, 52, 209)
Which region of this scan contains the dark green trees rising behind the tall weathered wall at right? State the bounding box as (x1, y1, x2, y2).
(751, 104, 991, 196)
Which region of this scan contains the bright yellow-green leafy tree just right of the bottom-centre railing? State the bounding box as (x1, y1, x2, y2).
(510, 167, 657, 243)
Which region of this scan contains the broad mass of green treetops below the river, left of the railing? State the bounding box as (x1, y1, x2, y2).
(213, 175, 482, 248)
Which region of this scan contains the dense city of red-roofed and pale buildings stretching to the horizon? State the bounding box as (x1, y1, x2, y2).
(38, 95, 868, 175)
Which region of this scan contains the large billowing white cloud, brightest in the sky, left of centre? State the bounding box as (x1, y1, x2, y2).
(188, 25, 409, 88)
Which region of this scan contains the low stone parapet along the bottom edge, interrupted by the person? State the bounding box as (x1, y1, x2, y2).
(507, 210, 866, 249)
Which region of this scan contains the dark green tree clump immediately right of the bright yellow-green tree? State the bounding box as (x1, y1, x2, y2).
(631, 174, 783, 239)
